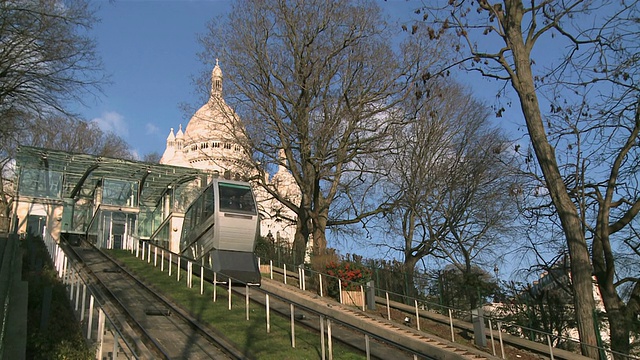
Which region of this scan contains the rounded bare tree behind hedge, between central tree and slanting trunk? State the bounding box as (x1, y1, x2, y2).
(385, 79, 515, 306)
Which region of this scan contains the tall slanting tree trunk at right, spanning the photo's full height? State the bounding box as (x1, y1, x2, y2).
(504, 0, 598, 359)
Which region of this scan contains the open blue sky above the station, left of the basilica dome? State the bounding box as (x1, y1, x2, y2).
(80, 0, 430, 157)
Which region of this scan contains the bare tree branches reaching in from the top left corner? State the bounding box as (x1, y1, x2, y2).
(0, 0, 103, 126)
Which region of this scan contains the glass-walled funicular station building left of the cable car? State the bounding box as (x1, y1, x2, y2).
(11, 146, 208, 252)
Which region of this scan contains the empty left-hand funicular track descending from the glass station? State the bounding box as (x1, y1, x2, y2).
(63, 243, 252, 359)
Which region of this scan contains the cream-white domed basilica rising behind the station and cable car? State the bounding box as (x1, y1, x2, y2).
(160, 61, 301, 248)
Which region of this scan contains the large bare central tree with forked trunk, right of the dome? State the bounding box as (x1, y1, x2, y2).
(202, 0, 420, 264)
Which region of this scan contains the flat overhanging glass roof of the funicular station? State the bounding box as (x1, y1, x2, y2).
(16, 146, 206, 206)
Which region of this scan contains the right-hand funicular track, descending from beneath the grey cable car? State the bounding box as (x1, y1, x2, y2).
(95, 242, 494, 360)
